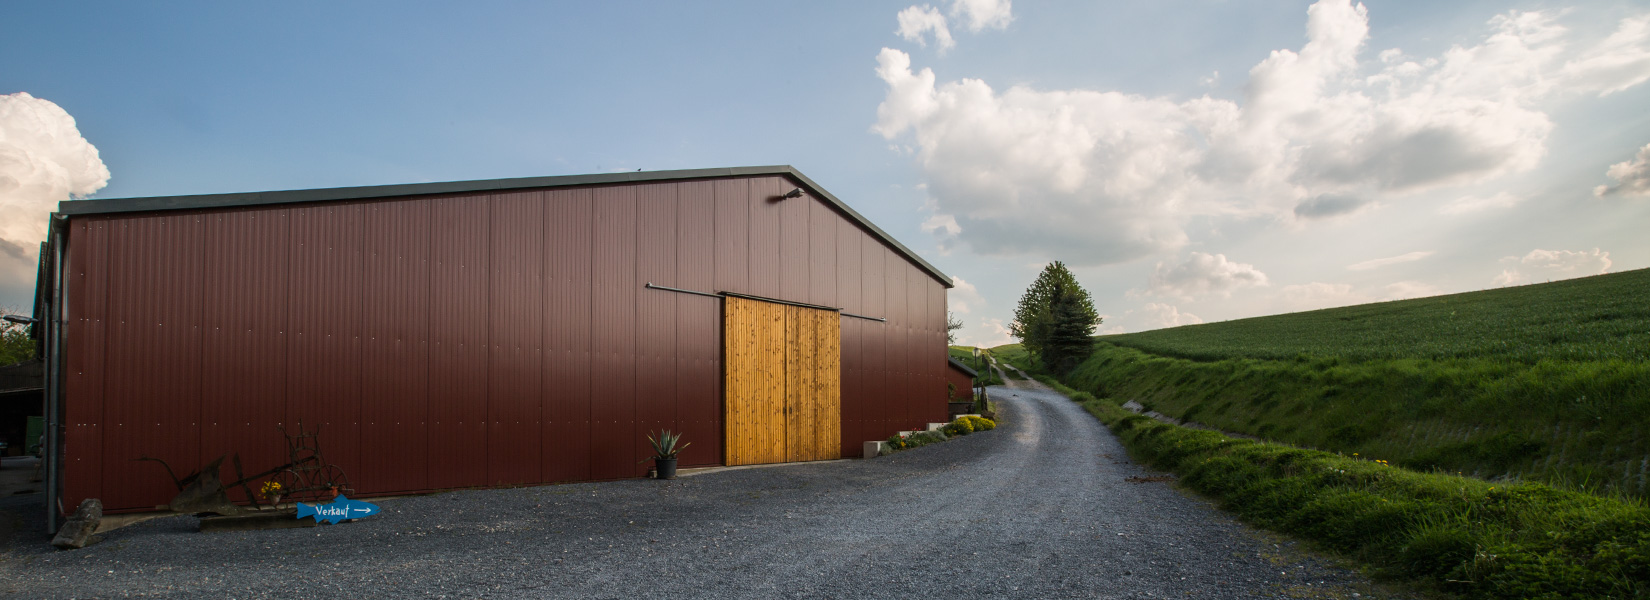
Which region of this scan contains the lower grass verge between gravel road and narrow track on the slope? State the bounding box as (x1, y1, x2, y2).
(1051, 381, 1650, 598)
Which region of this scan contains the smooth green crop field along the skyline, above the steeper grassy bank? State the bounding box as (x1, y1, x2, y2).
(1099, 269, 1650, 363)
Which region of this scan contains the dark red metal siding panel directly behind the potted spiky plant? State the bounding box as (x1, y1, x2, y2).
(629, 183, 681, 471)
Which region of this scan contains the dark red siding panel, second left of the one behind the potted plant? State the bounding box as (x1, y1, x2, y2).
(541, 190, 596, 481)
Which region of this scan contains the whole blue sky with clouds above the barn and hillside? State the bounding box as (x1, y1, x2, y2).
(0, 0, 1650, 345)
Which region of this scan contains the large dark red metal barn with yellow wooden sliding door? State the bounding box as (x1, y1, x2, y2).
(36, 166, 950, 513)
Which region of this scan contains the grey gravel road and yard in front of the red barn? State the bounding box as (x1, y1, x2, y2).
(0, 381, 1405, 598)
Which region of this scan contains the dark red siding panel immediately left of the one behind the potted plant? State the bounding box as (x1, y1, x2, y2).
(591, 186, 645, 480)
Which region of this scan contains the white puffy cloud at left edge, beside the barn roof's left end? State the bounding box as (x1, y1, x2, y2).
(0, 92, 109, 280)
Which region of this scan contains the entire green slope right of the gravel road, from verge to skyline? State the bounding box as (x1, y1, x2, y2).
(998, 270, 1650, 598)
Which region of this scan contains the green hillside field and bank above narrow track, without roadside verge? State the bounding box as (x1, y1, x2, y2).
(993, 270, 1650, 498)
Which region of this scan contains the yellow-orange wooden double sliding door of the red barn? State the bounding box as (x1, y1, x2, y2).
(723, 298, 842, 466)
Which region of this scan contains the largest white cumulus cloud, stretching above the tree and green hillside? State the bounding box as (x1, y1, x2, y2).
(873, 0, 1650, 265)
